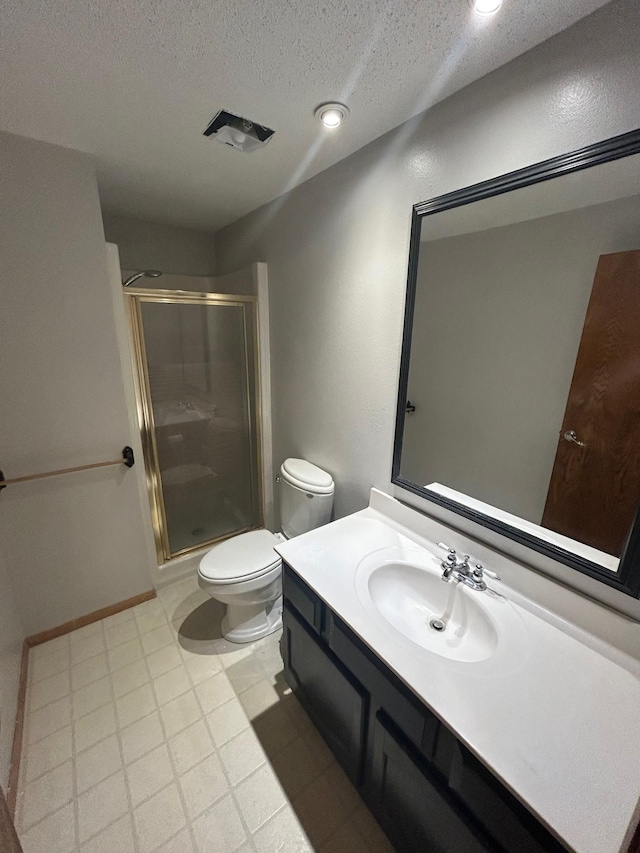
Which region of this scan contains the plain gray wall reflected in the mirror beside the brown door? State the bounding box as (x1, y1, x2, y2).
(401, 194, 640, 524)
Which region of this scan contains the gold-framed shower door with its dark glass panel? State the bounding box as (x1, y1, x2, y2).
(125, 288, 263, 562)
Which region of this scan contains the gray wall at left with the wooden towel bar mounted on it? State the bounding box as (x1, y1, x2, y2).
(0, 134, 151, 635)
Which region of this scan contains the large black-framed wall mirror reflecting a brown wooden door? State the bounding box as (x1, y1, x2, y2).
(392, 131, 640, 597)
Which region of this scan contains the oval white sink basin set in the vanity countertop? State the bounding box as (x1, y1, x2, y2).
(355, 548, 520, 663)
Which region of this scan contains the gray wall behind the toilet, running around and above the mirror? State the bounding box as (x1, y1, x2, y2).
(216, 0, 640, 516)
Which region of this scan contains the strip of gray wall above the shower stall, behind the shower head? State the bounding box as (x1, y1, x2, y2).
(102, 211, 215, 274)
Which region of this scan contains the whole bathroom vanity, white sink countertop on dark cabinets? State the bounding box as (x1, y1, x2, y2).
(277, 490, 640, 853)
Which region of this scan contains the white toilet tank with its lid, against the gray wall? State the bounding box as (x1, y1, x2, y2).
(280, 459, 334, 539)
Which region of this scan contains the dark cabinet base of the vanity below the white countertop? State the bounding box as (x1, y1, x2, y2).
(282, 564, 566, 853)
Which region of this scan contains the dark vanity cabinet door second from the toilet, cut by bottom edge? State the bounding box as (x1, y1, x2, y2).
(371, 713, 499, 853)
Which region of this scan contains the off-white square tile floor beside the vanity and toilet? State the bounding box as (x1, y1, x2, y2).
(16, 579, 391, 853)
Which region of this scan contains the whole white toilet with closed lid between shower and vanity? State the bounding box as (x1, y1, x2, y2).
(198, 459, 335, 643)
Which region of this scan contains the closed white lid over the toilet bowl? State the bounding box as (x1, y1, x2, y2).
(199, 530, 280, 583)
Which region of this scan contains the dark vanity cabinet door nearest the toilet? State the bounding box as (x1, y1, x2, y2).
(282, 604, 367, 784)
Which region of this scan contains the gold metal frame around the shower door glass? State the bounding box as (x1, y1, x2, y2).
(124, 287, 264, 564)
